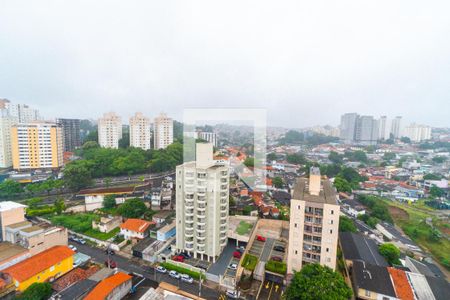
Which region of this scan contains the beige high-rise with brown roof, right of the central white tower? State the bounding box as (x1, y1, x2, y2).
(287, 167, 340, 274)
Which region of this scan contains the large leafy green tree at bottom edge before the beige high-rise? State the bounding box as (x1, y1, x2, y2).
(285, 264, 353, 300)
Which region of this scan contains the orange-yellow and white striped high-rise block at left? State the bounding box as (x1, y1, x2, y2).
(11, 121, 64, 170)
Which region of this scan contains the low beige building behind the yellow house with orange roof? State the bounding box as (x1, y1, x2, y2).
(5, 221, 68, 256)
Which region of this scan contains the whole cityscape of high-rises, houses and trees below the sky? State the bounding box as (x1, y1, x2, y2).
(0, 99, 450, 299)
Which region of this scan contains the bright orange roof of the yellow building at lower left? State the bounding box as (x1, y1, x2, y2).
(3, 246, 75, 282)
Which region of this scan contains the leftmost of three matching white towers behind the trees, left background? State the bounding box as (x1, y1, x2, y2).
(98, 112, 122, 149)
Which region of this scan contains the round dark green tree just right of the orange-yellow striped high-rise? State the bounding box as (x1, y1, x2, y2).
(63, 160, 92, 191)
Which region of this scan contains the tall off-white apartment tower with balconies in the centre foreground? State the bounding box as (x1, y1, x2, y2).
(176, 143, 230, 262)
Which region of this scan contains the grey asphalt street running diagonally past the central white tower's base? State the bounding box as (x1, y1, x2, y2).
(70, 242, 219, 299)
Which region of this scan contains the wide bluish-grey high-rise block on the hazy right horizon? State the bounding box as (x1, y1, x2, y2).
(340, 113, 378, 145)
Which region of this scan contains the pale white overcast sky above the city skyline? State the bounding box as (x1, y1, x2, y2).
(0, 0, 450, 127)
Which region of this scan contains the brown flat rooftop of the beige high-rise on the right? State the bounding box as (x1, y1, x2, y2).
(292, 178, 337, 204)
